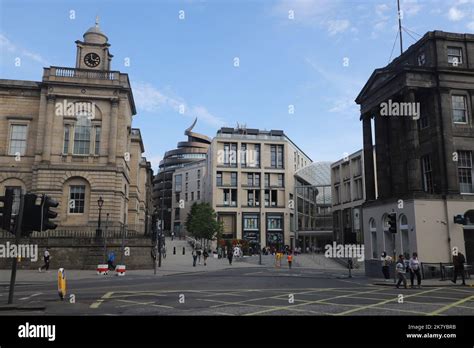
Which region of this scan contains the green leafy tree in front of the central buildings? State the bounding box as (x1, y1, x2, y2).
(186, 203, 223, 247)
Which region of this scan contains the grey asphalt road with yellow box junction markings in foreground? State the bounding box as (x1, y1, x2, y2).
(0, 266, 474, 316)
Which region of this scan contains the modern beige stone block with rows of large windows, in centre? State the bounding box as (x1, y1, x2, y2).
(204, 128, 311, 247)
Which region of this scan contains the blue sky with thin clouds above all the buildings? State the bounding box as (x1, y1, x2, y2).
(0, 0, 474, 170)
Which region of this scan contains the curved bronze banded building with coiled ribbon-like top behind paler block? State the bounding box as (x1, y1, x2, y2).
(153, 118, 212, 231)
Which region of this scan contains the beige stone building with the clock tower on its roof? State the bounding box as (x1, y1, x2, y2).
(0, 24, 152, 232)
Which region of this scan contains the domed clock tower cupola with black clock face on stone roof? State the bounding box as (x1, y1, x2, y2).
(76, 17, 113, 70)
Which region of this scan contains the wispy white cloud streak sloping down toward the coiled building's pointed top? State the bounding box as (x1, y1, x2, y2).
(133, 82, 225, 127)
